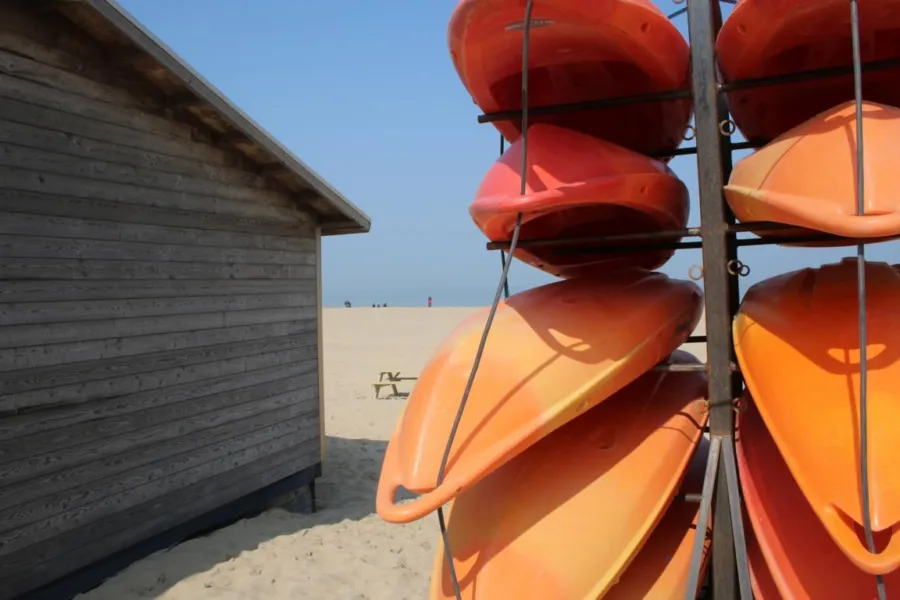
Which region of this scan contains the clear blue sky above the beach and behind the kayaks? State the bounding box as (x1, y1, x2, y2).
(120, 0, 900, 306)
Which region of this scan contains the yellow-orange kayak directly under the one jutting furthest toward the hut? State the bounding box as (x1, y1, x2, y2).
(431, 353, 708, 600)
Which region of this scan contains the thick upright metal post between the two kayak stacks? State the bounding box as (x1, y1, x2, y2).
(688, 0, 737, 600)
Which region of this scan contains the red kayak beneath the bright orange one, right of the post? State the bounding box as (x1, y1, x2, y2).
(737, 395, 900, 600)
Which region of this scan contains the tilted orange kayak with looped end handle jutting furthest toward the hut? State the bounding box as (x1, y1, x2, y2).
(376, 269, 702, 523)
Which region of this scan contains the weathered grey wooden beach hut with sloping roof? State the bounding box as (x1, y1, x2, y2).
(0, 0, 370, 599)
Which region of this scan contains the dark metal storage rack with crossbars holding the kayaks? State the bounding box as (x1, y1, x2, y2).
(450, 0, 900, 600)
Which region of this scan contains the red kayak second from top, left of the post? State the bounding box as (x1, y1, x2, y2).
(469, 125, 690, 277)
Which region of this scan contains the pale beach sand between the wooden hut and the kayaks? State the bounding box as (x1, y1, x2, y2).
(78, 307, 706, 600)
